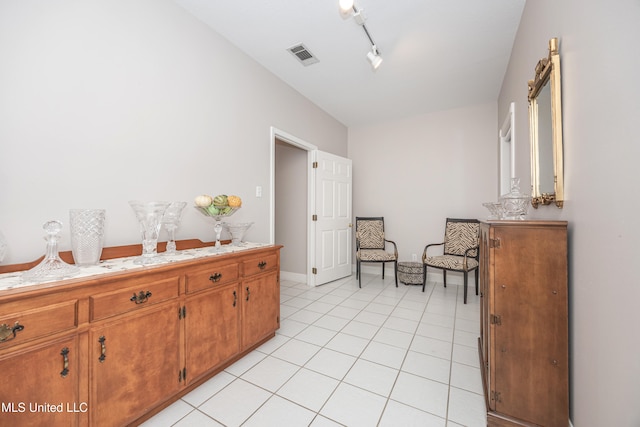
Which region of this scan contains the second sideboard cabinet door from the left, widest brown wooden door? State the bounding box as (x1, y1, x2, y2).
(89, 302, 182, 427)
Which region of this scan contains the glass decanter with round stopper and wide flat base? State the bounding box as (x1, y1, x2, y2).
(22, 221, 80, 282)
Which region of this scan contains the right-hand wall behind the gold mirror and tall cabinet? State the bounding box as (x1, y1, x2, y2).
(499, 0, 640, 427)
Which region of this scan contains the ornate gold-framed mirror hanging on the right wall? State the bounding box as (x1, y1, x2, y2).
(528, 38, 564, 208)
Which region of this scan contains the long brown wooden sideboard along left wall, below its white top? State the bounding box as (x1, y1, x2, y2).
(0, 243, 281, 427)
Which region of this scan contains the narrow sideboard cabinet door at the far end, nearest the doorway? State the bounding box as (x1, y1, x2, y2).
(241, 271, 280, 349)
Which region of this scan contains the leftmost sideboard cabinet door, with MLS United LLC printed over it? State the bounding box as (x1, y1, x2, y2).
(0, 336, 79, 427)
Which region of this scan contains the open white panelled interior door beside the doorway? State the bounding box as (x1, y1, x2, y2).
(314, 151, 353, 286)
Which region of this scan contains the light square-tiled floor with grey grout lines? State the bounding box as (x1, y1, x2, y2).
(143, 274, 486, 427)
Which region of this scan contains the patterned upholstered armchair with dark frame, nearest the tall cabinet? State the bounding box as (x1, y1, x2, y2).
(422, 218, 480, 304)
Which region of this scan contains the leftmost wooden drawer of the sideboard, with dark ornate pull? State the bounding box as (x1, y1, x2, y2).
(0, 300, 78, 349)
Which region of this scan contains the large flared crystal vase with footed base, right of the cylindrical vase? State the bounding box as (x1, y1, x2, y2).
(129, 200, 171, 265)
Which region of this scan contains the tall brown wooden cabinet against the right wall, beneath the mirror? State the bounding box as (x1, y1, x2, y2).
(479, 221, 569, 427)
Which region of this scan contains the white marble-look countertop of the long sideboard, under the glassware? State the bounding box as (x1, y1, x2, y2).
(0, 242, 271, 291)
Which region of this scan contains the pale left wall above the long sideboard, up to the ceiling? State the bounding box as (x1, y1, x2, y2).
(0, 0, 347, 264)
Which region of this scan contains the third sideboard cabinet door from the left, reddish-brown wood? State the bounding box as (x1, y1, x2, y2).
(185, 284, 240, 382)
